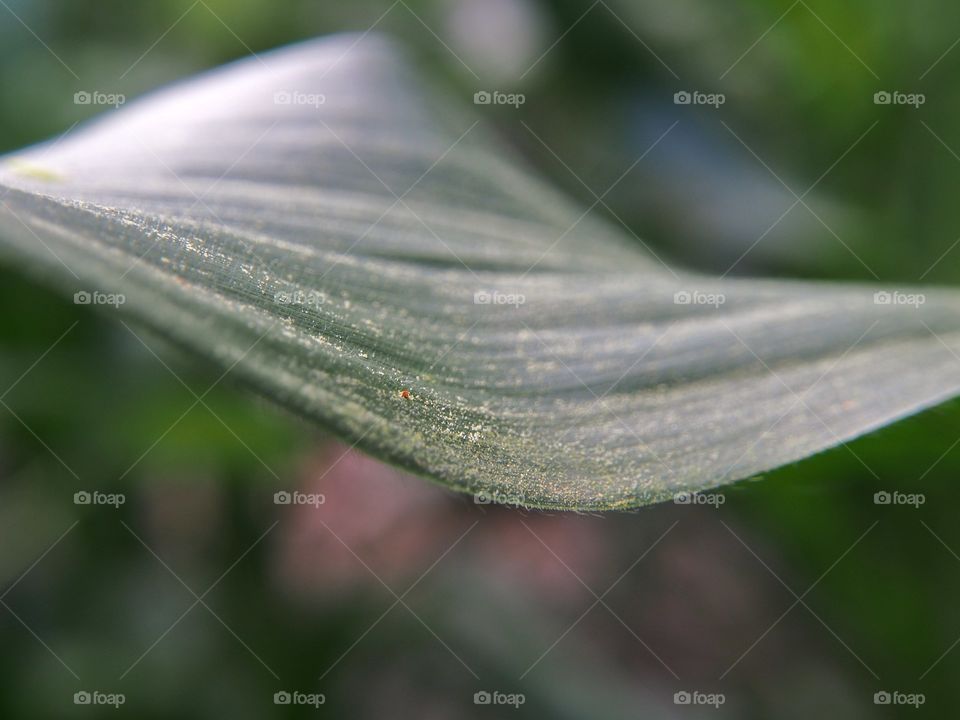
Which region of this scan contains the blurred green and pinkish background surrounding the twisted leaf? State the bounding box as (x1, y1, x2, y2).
(0, 0, 960, 719)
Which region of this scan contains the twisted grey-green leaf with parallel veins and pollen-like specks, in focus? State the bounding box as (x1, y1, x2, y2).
(0, 36, 960, 509)
